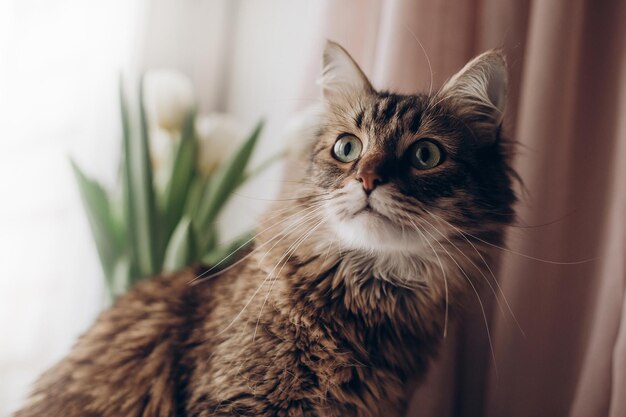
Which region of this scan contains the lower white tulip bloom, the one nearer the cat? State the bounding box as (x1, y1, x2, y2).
(195, 113, 244, 175)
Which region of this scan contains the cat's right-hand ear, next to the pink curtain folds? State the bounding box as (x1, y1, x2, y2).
(439, 50, 507, 138)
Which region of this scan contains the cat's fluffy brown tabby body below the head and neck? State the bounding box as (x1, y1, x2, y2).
(18, 247, 443, 416)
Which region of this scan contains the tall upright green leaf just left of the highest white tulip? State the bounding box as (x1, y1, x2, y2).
(120, 80, 158, 278)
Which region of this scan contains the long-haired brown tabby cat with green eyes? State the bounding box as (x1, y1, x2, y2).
(15, 42, 516, 417)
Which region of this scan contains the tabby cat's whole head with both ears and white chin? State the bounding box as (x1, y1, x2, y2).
(309, 43, 514, 253)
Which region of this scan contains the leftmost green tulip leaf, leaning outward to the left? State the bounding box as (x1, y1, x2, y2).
(70, 160, 124, 280)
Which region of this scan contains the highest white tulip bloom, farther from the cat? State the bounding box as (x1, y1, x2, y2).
(143, 70, 195, 132)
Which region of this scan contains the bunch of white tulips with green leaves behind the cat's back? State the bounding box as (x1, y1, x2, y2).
(72, 71, 274, 298)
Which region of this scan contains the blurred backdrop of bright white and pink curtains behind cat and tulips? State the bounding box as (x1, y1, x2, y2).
(0, 0, 626, 416)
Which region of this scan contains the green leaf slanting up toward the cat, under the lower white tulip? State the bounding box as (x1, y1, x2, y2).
(198, 121, 263, 228)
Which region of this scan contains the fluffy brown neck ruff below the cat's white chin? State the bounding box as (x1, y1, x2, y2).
(256, 221, 469, 321)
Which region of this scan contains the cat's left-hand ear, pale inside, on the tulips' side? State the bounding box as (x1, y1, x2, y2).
(318, 41, 374, 103)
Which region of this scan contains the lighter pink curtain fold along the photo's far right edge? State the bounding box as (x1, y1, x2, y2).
(571, 37, 626, 417)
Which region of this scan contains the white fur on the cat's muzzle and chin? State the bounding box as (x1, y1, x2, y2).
(326, 181, 424, 254)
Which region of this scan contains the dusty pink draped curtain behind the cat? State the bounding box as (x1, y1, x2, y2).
(304, 0, 626, 417)
